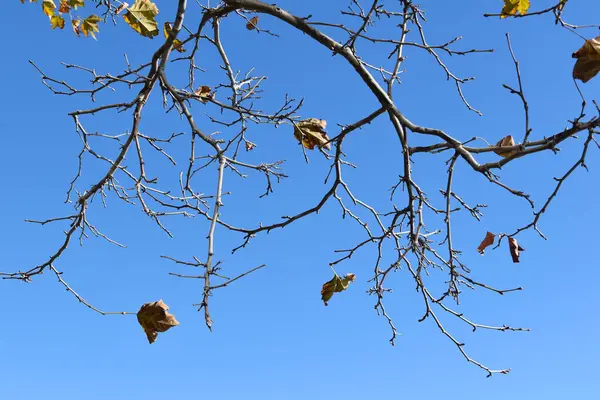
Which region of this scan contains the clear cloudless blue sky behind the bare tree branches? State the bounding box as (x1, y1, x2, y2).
(0, 0, 600, 400)
